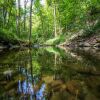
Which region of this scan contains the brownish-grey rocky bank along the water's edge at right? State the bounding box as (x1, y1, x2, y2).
(67, 35, 100, 47)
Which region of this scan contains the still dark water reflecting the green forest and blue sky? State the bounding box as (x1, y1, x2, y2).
(0, 47, 100, 100)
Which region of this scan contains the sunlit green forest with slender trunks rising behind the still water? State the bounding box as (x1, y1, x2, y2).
(0, 0, 100, 47)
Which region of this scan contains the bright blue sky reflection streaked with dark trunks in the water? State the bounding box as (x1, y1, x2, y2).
(18, 80, 46, 100)
